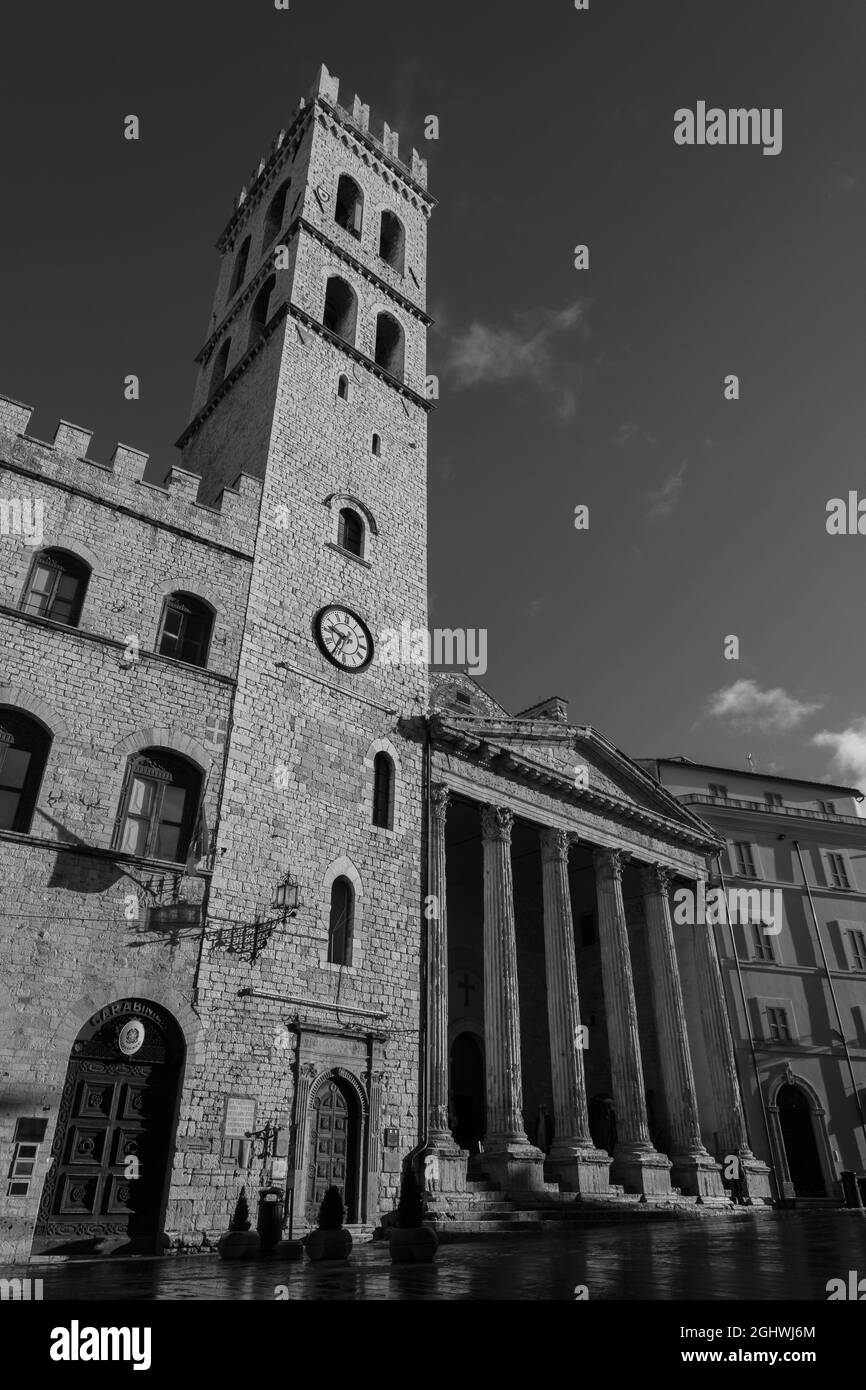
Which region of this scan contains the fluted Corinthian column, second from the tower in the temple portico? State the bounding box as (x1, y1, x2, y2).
(481, 806, 544, 1190)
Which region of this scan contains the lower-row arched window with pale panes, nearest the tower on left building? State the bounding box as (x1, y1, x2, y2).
(113, 748, 202, 863)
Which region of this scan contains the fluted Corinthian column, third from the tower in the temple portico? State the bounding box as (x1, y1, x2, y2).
(541, 830, 610, 1193)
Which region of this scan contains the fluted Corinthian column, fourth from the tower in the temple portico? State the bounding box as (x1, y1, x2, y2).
(592, 849, 670, 1195)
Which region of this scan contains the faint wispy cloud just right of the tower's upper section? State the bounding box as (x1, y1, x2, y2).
(446, 300, 588, 421)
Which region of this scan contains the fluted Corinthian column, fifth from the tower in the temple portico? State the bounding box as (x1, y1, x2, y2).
(641, 865, 726, 1201)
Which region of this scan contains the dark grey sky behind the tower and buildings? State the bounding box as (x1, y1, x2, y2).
(0, 0, 866, 783)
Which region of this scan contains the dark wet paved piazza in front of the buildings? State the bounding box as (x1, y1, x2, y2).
(11, 1211, 866, 1301)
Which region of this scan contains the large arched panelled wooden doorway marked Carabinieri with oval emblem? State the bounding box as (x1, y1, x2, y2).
(33, 999, 185, 1255)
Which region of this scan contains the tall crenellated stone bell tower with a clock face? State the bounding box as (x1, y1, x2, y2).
(167, 67, 434, 1220)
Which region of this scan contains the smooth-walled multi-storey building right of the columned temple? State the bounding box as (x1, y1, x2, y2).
(641, 758, 866, 1204)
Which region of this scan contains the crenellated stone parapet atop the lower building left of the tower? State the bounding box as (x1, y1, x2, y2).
(0, 396, 261, 555)
